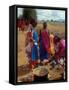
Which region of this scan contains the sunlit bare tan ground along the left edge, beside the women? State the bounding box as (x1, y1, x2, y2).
(18, 31, 28, 66)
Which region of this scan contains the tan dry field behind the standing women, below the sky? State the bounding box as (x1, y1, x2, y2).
(36, 23, 65, 37)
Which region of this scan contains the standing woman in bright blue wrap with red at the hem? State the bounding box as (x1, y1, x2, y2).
(31, 20, 38, 68)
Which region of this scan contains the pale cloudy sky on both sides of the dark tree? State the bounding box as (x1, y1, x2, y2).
(17, 8, 65, 21)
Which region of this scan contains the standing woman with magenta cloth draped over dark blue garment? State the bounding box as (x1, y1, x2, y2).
(39, 22, 50, 64)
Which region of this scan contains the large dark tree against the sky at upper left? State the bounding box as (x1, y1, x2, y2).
(23, 8, 37, 20)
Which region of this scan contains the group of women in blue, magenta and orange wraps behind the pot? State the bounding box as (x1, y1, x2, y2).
(18, 19, 65, 68)
